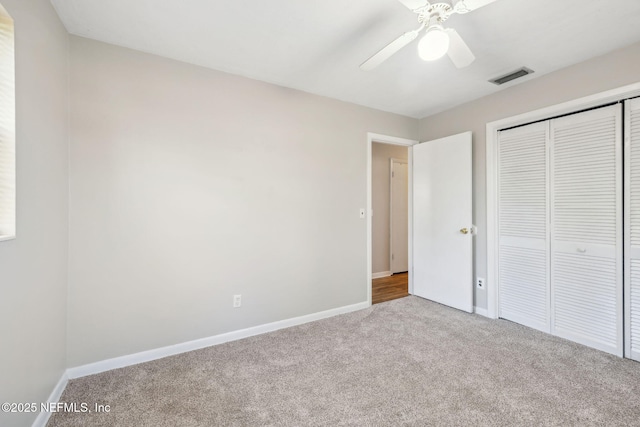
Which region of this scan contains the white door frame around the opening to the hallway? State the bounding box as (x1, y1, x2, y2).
(366, 132, 418, 306)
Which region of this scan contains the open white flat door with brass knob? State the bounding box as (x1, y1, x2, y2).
(413, 132, 473, 313)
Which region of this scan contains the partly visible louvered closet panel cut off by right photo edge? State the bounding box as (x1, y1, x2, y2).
(624, 99, 640, 361)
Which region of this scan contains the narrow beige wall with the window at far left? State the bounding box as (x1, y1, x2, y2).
(0, 0, 69, 426)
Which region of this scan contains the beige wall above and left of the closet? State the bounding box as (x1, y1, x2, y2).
(420, 43, 640, 308)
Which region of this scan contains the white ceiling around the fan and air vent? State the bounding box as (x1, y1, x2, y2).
(51, 0, 640, 118)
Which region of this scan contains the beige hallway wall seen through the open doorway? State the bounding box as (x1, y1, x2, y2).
(371, 142, 409, 273)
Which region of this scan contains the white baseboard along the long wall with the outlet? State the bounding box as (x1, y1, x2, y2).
(66, 301, 370, 379)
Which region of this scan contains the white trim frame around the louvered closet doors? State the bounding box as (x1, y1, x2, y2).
(485, 83, 640, 319)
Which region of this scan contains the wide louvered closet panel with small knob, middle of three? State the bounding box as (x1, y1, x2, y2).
(550, 105, 623, 356)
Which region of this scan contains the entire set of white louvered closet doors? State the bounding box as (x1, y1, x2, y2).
(498, 100, 640, 359)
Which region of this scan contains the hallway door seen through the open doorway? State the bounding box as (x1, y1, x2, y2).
(389, 159, 409, 274)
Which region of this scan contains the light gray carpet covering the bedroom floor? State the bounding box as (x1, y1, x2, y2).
(49, 297, 640, 426)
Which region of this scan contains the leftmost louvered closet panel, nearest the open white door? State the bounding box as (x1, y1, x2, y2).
(498, 122, 550, 332)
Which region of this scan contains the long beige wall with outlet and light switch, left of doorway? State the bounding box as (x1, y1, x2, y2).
(69, 37, 418, 367)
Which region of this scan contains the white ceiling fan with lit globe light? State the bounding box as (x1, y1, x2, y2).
(360, 0, 495, 71)
